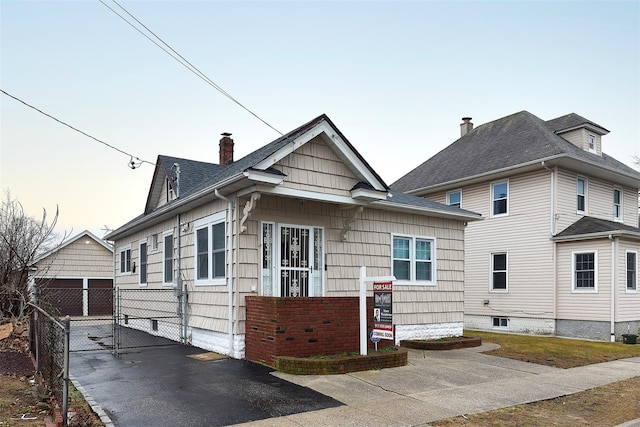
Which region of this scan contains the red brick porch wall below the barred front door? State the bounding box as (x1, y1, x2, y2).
(245, 296, 384, 366)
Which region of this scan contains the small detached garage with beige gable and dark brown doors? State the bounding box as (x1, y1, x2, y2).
(29, 230, 113, 316)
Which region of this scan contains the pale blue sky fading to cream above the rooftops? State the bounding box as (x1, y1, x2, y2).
(0, 0, 640, 242)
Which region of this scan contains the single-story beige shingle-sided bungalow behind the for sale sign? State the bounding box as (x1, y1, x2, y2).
(106, 115, 480, 358)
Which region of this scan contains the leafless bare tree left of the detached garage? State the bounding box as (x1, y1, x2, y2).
(0, 191, 58, 321)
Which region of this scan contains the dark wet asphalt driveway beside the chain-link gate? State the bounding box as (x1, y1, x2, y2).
(70, 345, 342, 427)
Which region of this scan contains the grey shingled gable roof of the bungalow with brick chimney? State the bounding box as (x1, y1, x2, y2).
(105, 114, 480, 240)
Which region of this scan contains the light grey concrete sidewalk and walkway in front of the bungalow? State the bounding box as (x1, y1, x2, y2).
(234, 344, 640, 427)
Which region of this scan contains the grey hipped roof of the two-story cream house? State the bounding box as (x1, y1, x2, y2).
(391, 111, 640, 194)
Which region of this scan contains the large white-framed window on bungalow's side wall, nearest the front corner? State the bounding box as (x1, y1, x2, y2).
(194, 212, 226, 285)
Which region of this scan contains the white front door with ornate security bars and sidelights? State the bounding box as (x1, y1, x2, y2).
(262, 223, 324, 297)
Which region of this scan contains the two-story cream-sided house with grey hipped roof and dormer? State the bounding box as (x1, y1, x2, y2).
(391, 111, 640, 341)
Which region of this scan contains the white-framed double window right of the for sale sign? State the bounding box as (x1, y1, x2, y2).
(392, 236, 436, 285)
